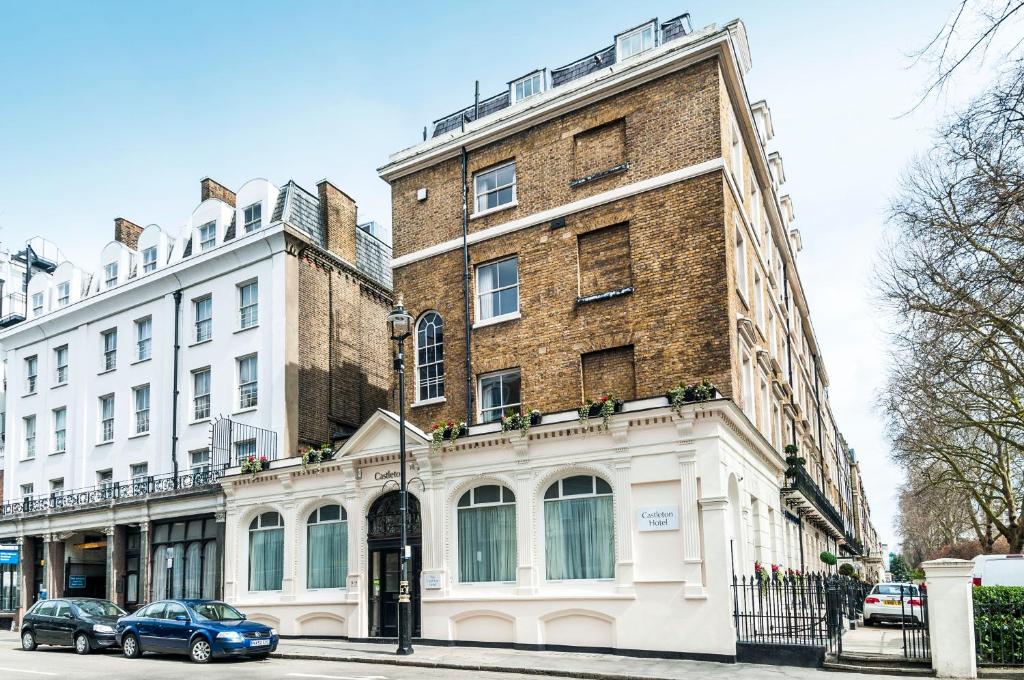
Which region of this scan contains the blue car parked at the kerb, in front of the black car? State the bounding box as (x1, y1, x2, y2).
(116, 600, 279, 664)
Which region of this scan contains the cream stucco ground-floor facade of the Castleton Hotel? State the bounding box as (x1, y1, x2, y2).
(222, 399, 806, 657)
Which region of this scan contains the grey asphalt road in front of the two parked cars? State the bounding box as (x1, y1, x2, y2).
(0, 636, 537, 680)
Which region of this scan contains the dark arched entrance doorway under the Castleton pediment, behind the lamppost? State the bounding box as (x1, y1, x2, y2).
(367, 492, 423, 637)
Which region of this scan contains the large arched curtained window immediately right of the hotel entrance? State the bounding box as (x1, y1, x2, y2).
(458, 484, 516, 583)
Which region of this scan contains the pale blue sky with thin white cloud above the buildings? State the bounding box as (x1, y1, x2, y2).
(0, 0, 972, 540)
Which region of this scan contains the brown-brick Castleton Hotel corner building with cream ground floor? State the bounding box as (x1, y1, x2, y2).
(224, 15, 880, 661)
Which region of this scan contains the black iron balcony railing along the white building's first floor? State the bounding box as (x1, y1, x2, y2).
(0, 467, 223, 517)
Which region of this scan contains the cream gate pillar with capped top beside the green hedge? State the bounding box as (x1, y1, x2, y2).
(921, 559, 978, 678)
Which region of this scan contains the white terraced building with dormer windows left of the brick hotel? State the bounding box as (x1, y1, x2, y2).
(0, 179, 390, 626)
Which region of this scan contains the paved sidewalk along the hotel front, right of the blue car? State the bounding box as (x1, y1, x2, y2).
(273, 639, 913, 680)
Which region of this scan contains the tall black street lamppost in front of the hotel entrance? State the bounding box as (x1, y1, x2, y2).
(387, 295, 413, 655)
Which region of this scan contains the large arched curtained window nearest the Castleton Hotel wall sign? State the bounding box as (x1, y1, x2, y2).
(544, 475, 615, 581)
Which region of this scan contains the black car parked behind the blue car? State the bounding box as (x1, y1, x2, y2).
(22, 597, 126, 654)
